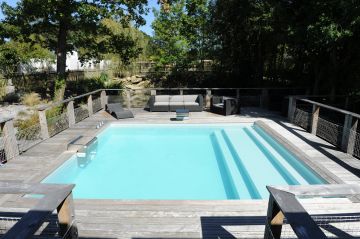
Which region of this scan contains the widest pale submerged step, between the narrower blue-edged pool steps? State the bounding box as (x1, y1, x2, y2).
(223, 129, 287, 199)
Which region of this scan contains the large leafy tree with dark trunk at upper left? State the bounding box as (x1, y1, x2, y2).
(0, 0, 147, 77)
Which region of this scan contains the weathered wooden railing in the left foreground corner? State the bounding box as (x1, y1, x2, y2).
(0, 182, 78, 239)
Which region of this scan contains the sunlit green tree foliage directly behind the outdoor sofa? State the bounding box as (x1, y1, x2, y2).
(152, 0, 208, 67)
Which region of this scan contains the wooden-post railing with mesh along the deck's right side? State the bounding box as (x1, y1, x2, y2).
(288, 96, 360, 158)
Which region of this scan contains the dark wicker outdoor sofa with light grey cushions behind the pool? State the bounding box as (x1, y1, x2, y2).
(149, 95, 204, 112)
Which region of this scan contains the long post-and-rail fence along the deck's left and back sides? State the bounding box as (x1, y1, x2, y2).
(0, 88, 304, 161)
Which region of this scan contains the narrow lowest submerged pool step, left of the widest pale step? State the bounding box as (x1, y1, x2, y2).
(214, 131, 255, 199)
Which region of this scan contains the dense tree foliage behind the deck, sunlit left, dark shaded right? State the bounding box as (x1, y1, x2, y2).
(152, 0, 360, 95)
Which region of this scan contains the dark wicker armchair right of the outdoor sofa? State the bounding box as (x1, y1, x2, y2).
(210, 96, 240, 116)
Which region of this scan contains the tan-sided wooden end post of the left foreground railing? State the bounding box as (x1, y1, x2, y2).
(57, 193, 78, 239)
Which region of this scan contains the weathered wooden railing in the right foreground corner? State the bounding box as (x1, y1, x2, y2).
(264, 184, 360, 239)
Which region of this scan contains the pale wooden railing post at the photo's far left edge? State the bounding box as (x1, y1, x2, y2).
(0, 118, 19, 162)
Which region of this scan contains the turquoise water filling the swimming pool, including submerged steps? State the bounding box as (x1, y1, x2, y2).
(43, 124, 325, 200)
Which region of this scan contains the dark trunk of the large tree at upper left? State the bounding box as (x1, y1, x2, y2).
(56, 21, 68, 78)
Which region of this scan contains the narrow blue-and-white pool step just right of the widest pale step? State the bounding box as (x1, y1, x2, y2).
(244, 128, 308, 185)
